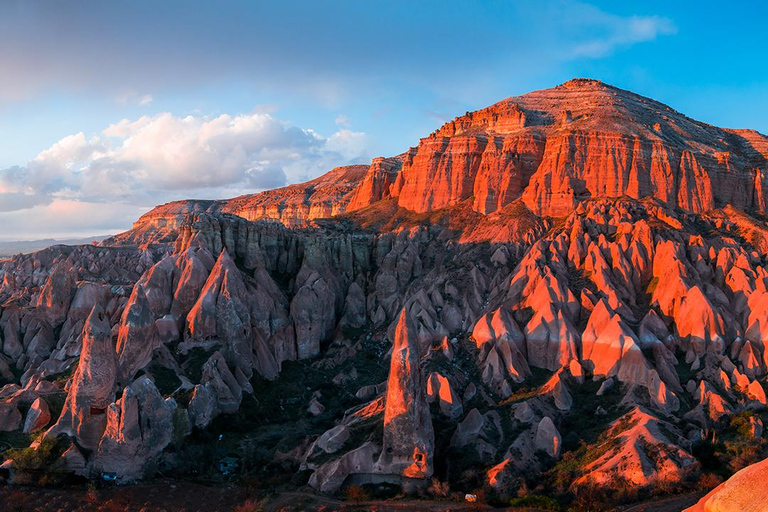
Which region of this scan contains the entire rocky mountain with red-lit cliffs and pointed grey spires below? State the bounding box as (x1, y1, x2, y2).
(0, 79, 768, 510)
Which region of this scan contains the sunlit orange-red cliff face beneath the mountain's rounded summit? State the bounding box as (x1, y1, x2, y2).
(350, 80, 768, 217)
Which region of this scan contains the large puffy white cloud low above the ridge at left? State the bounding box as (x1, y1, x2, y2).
(0, 111, 368, 236)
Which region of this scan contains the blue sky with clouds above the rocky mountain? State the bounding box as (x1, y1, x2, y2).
(0, 0, 768, 240)
